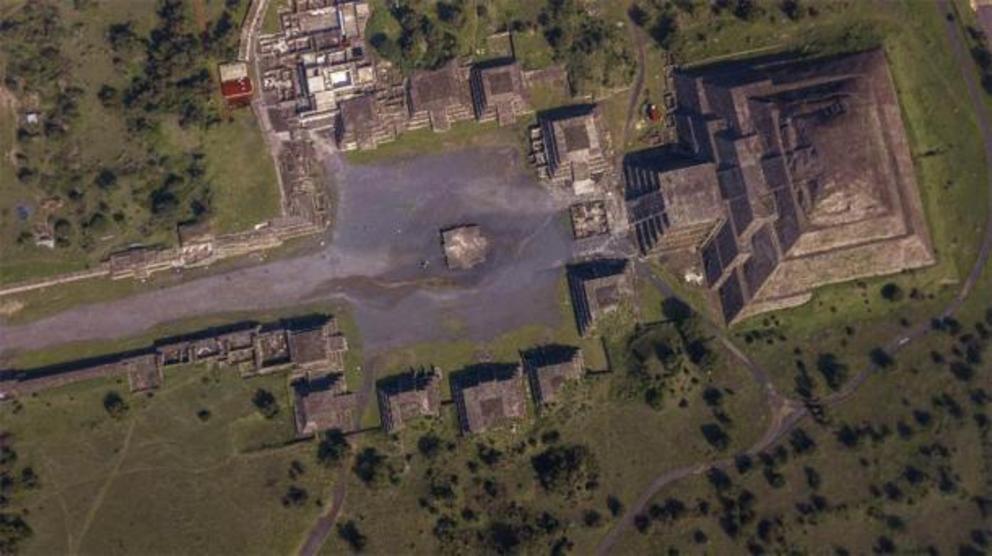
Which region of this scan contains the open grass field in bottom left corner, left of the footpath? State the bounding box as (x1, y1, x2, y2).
(0, 362, 334, 554)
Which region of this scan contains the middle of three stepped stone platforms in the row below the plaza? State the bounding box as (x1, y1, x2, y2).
(451, 364, 527, 434)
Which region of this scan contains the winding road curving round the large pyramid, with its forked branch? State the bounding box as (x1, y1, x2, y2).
(596, 0, 992, 555)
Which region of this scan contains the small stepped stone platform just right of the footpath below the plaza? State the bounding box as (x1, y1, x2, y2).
(376, 367, 441, 433)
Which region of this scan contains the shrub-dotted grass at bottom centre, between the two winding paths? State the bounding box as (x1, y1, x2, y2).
(323, 308, 768, 554)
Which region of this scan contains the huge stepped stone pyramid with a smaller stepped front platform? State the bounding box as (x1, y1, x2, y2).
(625, 50, 934, 322)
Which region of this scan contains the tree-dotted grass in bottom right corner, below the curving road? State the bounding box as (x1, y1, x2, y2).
(616, 310, 992, 554)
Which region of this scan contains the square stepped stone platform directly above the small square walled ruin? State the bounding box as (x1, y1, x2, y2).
(535, 106, 610, 195)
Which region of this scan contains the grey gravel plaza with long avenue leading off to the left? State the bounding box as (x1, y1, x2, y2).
(0, 148, 572, 358)
